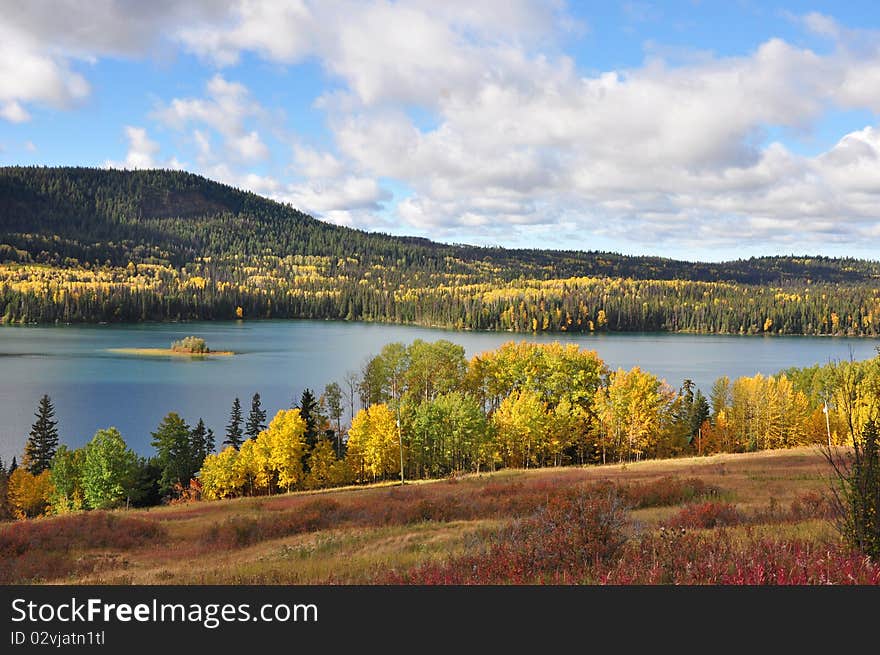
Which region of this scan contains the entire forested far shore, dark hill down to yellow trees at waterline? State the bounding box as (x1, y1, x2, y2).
(0, 167, 880, 334)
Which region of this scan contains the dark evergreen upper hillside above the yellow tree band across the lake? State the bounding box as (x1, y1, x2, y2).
(0, 167, 880, 284)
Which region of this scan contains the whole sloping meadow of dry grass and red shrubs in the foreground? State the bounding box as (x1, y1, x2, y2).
(0, 448, 880, 584)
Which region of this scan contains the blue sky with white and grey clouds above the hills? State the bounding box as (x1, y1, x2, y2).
(0, 0, 880, 261)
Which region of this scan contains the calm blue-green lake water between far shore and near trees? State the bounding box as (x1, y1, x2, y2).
(0, 320, 880, 463)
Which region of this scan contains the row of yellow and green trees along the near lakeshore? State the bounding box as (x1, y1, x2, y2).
(0, 340, 880, 518)
